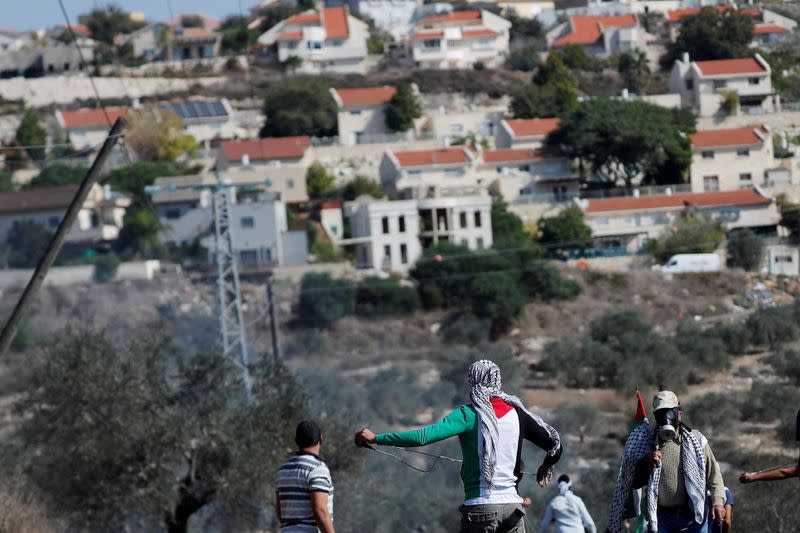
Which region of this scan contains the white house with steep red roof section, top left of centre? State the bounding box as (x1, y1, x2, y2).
(258, 7, 369, 74)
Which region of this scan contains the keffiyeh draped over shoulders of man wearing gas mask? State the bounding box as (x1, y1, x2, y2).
(608, 420, 708, 533)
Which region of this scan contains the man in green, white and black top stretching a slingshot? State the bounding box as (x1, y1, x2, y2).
(355, 360, 563, 533)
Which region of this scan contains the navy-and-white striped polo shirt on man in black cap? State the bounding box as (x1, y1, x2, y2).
(275, 452, 333, 533)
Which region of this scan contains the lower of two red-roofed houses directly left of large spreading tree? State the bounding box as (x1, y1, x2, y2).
(479, 148, 580, 202)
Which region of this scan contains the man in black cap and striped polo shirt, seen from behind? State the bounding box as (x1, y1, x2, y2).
(275, 420, 334, 533)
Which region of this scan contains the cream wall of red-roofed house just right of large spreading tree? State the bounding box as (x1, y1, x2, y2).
(690, 139, 775, 192)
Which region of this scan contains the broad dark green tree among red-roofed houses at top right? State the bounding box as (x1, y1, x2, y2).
(661, 7, 753, 69)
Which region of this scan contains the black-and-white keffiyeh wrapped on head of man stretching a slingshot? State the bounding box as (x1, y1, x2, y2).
(468, 359, 561, 487)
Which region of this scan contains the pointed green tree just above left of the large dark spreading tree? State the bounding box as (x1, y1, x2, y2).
(511, 54, 578, 118)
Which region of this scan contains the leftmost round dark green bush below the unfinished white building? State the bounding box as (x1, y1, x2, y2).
(297, 273, 356, 328)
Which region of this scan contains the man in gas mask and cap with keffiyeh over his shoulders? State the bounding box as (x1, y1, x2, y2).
(608, 391, 725, 533)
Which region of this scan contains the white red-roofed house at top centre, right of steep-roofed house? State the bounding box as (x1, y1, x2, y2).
(410, 10, 511, 69)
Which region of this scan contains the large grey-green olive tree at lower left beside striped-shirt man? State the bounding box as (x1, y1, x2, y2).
(12, 332, 336, 531)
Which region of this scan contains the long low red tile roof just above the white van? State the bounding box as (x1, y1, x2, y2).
(585, 189, 772, 213)
